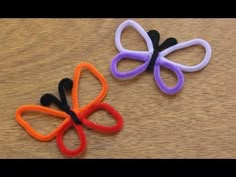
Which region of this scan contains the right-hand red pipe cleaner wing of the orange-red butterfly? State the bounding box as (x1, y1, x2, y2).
(78, 103, 123, 133)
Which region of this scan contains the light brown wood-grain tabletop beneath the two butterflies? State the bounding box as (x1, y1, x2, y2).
(0, 18, 236, 158)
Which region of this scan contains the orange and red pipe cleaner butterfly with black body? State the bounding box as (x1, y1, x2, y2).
(16, 62, 123, 156)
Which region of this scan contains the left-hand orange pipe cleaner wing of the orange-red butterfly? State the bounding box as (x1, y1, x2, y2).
(16, 105, 70, 141)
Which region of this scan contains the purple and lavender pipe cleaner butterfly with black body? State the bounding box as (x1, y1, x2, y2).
(110, 20, 211, 95)
